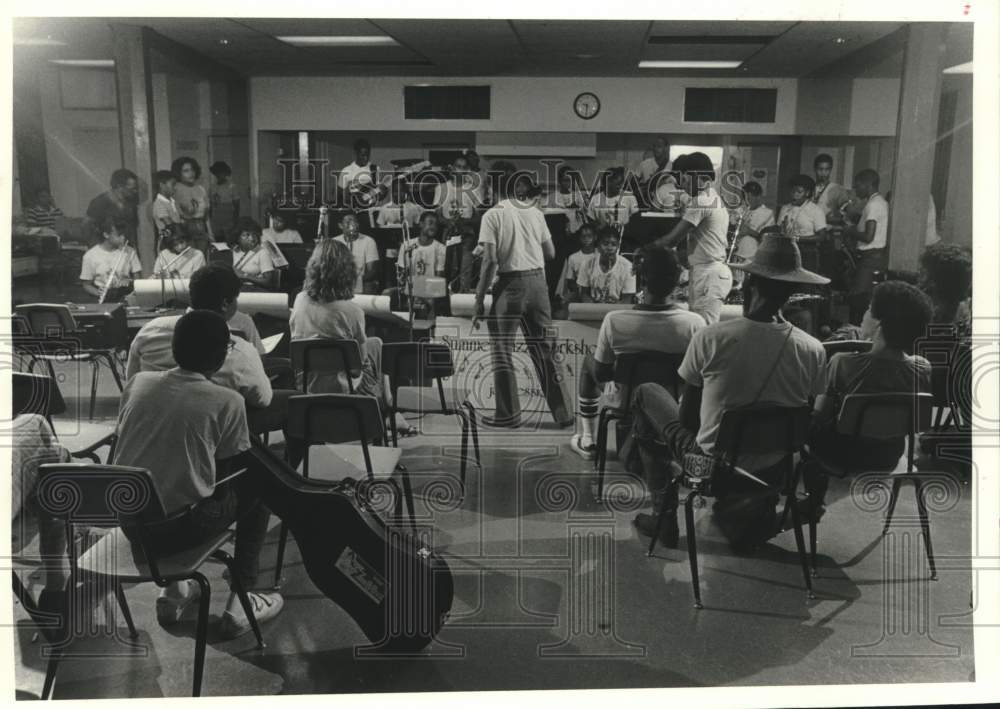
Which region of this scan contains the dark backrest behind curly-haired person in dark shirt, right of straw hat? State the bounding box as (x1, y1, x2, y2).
(837, 392, 934, 439)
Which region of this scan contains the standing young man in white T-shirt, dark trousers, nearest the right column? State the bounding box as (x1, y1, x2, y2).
(844, 168, 889, 325)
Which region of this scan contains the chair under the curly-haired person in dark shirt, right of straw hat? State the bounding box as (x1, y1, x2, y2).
(803, 393, 937, 580)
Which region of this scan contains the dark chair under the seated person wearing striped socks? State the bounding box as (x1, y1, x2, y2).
(594, 350, 684, 502)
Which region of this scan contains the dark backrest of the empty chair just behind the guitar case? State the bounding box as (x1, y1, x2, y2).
(285, 394, 388, 445)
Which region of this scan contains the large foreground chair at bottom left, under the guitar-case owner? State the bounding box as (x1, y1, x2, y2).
(32, 464, 264, 697)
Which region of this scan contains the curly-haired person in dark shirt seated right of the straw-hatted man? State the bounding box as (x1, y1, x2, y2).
(803, 281, 931, 519)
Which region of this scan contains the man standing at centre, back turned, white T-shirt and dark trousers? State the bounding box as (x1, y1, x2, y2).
(473, 162, 573, 428)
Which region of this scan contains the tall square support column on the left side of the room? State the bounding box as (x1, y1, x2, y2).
(111, 24, 156, 274)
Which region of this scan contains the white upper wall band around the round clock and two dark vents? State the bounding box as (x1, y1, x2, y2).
(251, 77, 800, 135)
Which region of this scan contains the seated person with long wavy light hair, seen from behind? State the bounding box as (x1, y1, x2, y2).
(289, 239, 416, 435)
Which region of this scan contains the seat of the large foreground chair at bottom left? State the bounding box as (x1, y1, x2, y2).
(77, 527, 235, 581)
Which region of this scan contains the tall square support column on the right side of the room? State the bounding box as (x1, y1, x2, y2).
(889, 22, 947, 271)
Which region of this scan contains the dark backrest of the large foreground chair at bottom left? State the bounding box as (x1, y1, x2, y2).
(36, 463, 166, 527)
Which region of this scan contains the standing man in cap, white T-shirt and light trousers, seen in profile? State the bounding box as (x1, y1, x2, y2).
(654, 153, 733, 325)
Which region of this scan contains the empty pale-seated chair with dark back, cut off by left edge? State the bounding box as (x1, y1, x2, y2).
(11, 372, 117, 463)
